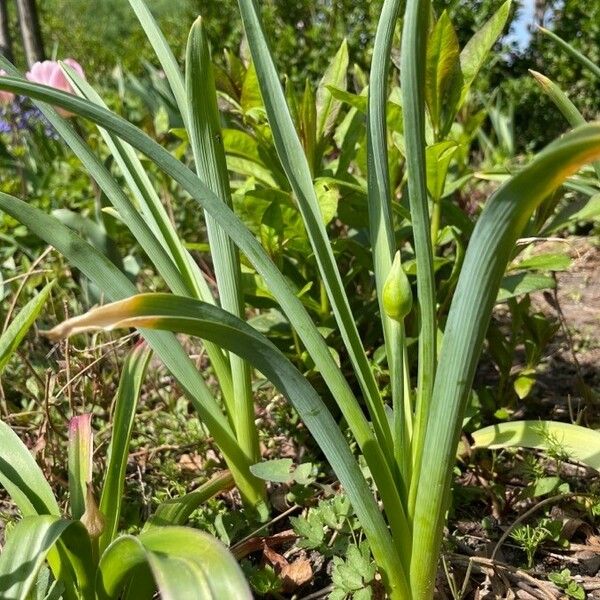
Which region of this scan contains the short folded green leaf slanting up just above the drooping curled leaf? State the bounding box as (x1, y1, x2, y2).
(144, 471, 234, 530)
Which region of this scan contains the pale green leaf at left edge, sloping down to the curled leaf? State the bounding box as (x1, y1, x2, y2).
(0, 421, 60, 516)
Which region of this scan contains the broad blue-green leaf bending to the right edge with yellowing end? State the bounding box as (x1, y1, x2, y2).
(411, 125, 600, 598)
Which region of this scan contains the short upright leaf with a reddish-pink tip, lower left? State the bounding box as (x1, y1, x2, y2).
(68, 413, 94, 519)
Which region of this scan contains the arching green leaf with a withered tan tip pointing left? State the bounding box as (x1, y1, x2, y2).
(49, 294, 407, 597)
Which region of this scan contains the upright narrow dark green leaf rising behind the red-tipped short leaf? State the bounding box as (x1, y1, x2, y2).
(99, 344, 152, 553)
